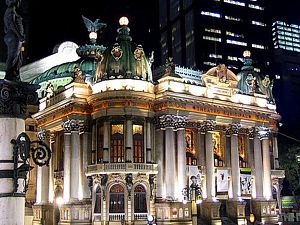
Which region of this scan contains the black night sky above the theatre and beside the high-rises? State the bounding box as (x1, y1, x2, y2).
(0, 0, 300, 63)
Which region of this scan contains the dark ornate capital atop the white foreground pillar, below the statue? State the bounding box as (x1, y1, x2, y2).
(0, 80, 40, 118)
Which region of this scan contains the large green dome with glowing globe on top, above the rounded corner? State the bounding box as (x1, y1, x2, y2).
(95, 17, 152, 82)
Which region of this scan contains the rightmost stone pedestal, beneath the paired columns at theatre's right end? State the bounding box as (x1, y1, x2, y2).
(252, 200, 279, 224)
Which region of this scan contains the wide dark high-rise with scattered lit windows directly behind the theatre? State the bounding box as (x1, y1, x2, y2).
(159, 0, 270, 72)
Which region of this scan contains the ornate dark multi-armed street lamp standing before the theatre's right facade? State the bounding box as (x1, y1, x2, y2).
(182, 176, 202, 225)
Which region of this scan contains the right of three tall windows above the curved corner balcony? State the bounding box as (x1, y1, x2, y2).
(133, 124, 144, 163)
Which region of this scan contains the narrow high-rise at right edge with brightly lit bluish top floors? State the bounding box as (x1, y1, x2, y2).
(272, 21, 300, 138)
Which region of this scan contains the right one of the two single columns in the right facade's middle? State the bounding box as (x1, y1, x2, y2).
(230, 124, 241, 200)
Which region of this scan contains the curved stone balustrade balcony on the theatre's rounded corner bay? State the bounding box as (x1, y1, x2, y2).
(86, 163, 157, 176)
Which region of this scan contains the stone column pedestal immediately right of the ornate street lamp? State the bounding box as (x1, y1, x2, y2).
(200, 201, 221, 225)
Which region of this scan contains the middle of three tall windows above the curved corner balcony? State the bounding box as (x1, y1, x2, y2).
(110, 124, 125, 163)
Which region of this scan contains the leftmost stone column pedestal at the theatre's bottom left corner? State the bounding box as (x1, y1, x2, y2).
(32, 204, 55, 225)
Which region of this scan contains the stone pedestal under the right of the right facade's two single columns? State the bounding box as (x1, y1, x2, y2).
(227, 200, 247, 225)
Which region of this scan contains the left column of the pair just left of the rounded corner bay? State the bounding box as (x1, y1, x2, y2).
(63, 120, 71, 203)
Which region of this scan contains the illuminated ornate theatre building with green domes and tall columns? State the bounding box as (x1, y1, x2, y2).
(23, 18, 284, 225)
